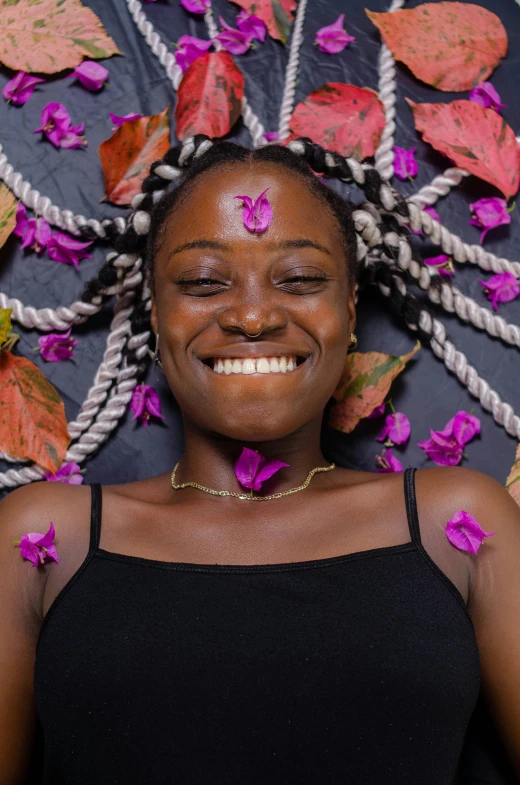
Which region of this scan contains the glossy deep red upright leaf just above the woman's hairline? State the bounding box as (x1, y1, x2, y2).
(175, 52, 244, 139)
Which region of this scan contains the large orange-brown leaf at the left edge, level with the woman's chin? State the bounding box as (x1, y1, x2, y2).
(0, 350, 70, 472)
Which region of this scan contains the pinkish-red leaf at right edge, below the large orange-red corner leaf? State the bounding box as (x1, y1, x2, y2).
(406, 99, 520, 197)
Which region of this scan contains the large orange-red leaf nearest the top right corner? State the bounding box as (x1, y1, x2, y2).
(365, 2, 507, 92)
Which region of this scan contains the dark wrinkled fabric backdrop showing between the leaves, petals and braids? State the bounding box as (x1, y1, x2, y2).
(0, 0, 520, 785)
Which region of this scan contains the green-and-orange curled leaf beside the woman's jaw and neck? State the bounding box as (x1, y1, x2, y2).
(328, 341, 421, 433)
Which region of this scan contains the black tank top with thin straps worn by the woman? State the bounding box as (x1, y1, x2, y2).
(35, 467, 480, 785)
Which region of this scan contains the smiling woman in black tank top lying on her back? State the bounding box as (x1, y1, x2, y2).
(0, 138, 520, 785)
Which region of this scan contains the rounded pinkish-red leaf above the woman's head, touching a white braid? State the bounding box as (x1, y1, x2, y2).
(290, 82, 385, 161)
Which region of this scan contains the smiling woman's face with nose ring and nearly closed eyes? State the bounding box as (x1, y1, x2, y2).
(148, 163, 355, 441)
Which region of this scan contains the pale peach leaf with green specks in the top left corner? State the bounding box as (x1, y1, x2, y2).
(0, 0, 121, 74)
